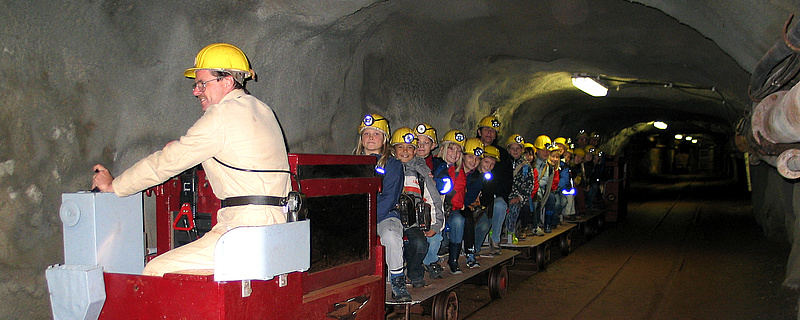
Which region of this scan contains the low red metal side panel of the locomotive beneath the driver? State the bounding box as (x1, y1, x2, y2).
(100, 273, 303, 320)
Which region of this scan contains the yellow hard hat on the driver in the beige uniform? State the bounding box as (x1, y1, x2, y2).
(183, 43, 255, 79)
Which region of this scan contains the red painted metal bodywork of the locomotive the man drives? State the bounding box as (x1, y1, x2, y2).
(100, 154, 386, 319)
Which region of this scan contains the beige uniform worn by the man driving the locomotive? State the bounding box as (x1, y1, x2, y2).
(113, 89, 291, 276)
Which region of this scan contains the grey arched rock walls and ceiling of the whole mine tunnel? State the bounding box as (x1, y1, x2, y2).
(0, 0, 800, 319)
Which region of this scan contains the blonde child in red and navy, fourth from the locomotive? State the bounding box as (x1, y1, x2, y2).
(433, 130, 467, 274)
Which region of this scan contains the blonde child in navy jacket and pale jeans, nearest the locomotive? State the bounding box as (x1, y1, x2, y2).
(353, 114, 411, 302)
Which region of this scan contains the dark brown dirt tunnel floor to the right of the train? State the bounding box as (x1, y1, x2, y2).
(444, 178, 798, 320)
